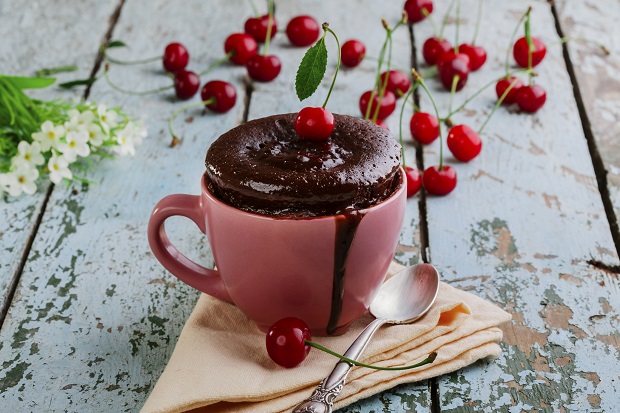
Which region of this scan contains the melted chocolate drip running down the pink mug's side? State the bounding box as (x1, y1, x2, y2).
(327, 210, 364, 335)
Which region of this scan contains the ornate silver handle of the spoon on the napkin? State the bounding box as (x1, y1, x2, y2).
(293, 318, 386, 413)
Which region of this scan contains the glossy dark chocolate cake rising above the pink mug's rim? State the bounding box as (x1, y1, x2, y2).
(205, 113, 400, 217)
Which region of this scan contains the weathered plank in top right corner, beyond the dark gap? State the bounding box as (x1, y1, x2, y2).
(554, 0, 620, 258)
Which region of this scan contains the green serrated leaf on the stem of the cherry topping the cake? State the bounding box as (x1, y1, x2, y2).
(295, 38, 327, 101)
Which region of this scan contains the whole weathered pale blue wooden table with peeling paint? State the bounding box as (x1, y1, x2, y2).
(0, 0, 620, 413)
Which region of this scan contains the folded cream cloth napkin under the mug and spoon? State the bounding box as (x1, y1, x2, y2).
(141, 263, 510, 413)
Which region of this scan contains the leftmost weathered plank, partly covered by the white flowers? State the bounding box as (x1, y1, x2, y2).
(0, 0, 116, 316)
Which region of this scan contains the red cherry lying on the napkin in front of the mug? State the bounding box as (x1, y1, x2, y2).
(266, 317, 312, 368)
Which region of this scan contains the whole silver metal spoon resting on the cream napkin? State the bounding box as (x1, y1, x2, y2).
(293, 264, 439, 413)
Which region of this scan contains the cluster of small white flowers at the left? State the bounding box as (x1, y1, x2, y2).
(0, 103, 146, 196)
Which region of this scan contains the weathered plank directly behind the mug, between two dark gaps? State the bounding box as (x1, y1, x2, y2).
(241, 1, 430, 413)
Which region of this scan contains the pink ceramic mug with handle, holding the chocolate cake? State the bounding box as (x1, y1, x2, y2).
(148, 169, 407, 335)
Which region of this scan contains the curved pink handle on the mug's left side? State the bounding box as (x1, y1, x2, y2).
(148, 194, 233, 303)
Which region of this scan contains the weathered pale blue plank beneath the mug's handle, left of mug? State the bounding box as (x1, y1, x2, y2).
(0, 0, 251, 412)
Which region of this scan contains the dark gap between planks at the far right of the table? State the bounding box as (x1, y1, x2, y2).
(548, 0, 620, 262)
